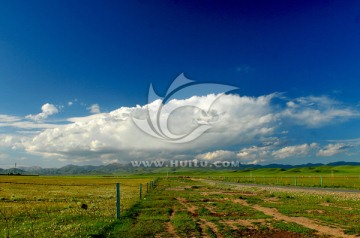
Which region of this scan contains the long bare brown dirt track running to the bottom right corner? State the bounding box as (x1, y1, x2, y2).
(233, 199, 356, 238)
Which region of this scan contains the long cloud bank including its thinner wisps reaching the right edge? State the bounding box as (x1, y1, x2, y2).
(19, 94, 358, 163)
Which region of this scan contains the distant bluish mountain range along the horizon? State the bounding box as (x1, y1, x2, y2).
(0, 161, 360, 175)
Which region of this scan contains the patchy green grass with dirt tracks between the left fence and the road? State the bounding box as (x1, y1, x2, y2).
(110, 177, 360, 238)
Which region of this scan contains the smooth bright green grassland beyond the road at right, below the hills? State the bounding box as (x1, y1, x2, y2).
(140, 165, 360, 190)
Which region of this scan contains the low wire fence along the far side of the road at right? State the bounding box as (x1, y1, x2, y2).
(208, 176, 360, 189)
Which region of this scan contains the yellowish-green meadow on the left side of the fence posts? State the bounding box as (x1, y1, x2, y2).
(0, 176, 154, 237)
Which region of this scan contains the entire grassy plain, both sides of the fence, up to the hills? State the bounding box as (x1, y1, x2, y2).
(0, 166, 360, 237)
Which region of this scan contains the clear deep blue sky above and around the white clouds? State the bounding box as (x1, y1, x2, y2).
(0, 0, 360, 167)
